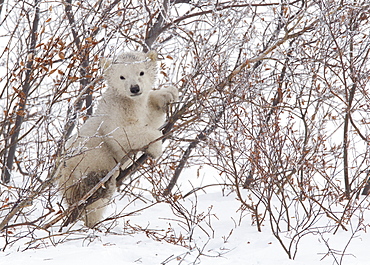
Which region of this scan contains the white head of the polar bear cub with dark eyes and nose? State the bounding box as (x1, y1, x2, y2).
(101, 51, 157, 99)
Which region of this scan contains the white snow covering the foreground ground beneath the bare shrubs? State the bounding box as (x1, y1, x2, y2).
(0, 185, 370, 265)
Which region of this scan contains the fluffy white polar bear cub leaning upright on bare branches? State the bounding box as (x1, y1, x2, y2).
(58, 51, 178, 227)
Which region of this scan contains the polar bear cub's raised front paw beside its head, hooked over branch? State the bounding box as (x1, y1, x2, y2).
(149, 86, 179, 112)
